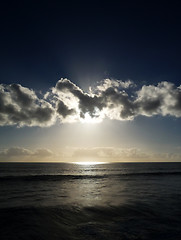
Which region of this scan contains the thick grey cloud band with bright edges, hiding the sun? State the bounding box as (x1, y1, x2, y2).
(0, 79, 181, 127)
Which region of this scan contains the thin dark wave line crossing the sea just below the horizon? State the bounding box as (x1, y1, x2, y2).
(0, 171, 181, 181)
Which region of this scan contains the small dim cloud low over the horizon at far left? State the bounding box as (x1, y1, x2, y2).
(0, 147, 54, 161)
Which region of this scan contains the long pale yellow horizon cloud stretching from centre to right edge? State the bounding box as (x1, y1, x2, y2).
(65, 147, 181, 162)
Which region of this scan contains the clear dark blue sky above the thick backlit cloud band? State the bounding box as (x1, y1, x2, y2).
(0, 1, 181, 90)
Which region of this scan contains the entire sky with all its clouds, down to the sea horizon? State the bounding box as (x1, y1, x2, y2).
(0, 1, 181, 162)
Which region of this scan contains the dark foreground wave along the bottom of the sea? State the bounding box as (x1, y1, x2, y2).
(0, 202, 181, 240)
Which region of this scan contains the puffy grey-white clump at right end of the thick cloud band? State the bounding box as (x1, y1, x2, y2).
(135, 81, 181, 117)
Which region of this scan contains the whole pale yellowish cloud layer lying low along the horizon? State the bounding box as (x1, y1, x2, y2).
(0, 147, 181, 162)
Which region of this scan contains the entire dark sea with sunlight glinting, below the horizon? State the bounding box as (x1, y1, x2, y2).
(0, 163, 181, 240)
